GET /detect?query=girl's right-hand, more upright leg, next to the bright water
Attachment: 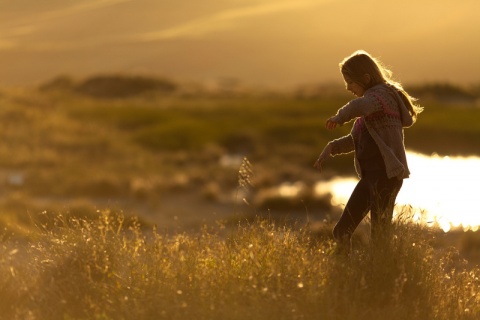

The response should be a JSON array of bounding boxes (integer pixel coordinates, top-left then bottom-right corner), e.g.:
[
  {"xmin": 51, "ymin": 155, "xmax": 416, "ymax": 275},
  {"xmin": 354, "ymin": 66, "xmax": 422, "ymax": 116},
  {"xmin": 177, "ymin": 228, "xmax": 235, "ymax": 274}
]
[{"xmin": 370, "ymin": 178, "xmax": 403, "ymax": 242}]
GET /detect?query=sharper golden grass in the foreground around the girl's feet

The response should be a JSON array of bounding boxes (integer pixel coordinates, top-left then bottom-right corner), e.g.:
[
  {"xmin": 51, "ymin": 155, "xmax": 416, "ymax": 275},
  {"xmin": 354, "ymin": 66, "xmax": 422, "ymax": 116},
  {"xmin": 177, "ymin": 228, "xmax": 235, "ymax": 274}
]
[{"xmin": 0, "ymin": 211, "xmax": 480, "ymax": 319}]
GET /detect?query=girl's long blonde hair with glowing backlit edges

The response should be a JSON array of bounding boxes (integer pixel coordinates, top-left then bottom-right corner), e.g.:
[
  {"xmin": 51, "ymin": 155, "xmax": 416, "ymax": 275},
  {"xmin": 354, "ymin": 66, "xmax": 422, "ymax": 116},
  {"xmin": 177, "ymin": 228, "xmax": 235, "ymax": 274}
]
[{"xmin": 340, "ymin": 50, "xmax": 423, "ymax": 121}]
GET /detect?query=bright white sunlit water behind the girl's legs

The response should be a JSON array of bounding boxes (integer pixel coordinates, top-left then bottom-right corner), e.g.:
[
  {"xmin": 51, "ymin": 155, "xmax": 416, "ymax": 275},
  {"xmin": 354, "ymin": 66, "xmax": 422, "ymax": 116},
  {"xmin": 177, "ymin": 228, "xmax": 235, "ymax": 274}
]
[{"xmin": 315, "ymin": 152, "xmax": 480, "ymax": 232}]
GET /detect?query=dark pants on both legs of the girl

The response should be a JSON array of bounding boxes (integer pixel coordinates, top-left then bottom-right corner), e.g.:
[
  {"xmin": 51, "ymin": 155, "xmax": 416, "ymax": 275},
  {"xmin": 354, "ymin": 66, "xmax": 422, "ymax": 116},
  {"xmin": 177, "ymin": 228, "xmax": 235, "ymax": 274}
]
[{"xmin": 333, "ymin": 171, "xmax": 403, "ymax": 247}]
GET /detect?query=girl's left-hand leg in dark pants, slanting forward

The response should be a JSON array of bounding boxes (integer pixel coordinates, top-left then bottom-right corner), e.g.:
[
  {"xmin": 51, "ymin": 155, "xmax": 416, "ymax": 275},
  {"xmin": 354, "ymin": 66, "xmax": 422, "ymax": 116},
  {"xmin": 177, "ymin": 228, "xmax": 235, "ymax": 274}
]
[{"xmin": 333, "ymin": 178, "xmax": 372, "ymax": 251}]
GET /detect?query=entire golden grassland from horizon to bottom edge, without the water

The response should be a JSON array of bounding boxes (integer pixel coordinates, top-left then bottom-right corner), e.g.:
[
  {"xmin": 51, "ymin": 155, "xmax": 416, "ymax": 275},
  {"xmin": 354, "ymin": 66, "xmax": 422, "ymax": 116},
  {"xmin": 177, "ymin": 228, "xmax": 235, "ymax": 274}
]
[{"xmin": 0, "ymin": 78, "xmax": 480, "ymax": 319}]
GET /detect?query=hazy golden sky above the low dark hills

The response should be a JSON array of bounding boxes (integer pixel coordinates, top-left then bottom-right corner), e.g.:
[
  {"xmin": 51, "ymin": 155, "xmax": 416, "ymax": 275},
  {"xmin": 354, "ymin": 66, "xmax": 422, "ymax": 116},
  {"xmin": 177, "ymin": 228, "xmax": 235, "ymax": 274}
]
[{"xmin": 0, "ymin": 0, "xmax": 480, "ymax": 87}]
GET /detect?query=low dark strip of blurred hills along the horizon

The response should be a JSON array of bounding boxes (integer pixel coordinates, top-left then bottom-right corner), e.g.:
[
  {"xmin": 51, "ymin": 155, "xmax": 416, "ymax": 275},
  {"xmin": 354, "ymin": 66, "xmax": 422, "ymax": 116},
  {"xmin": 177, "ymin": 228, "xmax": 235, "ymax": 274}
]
[{"xmin": 39, "ymin": 74, "xmax": 480, "ymax": 105}]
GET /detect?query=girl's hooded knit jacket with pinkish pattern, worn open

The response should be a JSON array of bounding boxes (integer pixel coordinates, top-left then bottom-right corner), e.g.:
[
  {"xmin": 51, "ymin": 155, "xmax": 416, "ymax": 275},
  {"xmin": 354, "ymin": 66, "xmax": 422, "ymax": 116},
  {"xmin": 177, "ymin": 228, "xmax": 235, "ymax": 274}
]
[{"xmin": 329, "ymin": 83, "xmax": 414, "ymax": 180}]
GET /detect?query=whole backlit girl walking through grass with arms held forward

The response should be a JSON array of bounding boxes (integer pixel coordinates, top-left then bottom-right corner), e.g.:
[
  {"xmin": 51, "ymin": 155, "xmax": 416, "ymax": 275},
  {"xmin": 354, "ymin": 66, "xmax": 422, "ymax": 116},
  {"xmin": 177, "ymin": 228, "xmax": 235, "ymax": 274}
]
[{"xmin": 314, "ymin": 51, "xmax": 422, "ymax": 252}]
